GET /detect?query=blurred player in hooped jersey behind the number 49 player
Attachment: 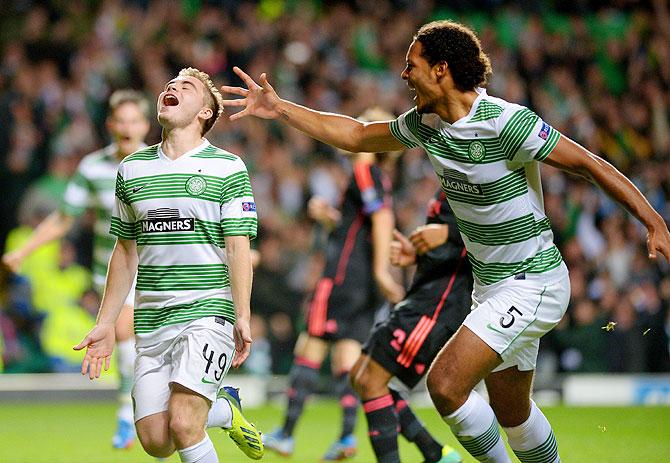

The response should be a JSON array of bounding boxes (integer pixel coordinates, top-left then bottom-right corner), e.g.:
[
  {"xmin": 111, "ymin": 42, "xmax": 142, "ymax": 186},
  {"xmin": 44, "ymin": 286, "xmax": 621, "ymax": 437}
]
[{"xmin": 2, "ymin": 90, "xmax": 149, "ymax": 448}]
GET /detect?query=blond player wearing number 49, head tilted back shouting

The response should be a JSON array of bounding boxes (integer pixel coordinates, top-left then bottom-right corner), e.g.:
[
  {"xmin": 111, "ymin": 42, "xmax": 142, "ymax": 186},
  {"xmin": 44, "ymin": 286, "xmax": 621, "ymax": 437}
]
[{"xmin": 75, "ymin": 68, "xmax": 263, "ymax": 463}]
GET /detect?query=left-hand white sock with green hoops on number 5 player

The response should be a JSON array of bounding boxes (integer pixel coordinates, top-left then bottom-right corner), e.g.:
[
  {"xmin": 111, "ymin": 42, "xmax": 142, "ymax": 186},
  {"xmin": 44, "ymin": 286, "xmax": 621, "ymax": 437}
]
[{"xmin": 442, "ymin": 391, "xmax": 512, "ymax": 463}]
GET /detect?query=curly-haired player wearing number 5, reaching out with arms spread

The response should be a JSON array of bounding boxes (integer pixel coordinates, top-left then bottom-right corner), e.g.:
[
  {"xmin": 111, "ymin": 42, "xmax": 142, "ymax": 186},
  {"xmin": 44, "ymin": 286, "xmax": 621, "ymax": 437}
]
[{"xmin": 223, "ymin": 21, "xmax": 670, "ymax": 463}]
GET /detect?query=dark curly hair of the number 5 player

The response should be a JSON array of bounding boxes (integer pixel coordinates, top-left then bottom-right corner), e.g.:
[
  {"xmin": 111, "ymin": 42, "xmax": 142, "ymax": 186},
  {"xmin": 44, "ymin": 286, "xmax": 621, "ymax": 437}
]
[{"xmin": 414, "ymin": 20, "xmax": 493, "ymax": 91}]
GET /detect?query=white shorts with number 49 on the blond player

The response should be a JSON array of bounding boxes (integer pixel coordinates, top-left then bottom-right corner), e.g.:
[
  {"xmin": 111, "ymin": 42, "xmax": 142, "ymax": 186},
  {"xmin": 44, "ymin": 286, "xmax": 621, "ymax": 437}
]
[{"xmin": 132, "ymin": 317, "xmax": 235, "ymax": 421}]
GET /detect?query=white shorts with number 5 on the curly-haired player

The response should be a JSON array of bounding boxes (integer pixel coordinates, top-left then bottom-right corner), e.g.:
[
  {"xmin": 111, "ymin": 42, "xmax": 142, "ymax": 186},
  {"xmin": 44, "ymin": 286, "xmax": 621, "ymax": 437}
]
[{"xmin": 463, "ymin": 264, "xmax": 570, "ymax": 371}]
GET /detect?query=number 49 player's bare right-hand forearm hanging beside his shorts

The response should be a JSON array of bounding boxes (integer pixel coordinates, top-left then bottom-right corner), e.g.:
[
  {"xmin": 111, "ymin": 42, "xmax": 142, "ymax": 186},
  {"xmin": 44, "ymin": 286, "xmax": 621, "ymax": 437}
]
[{"xmin": 225, "ymin": 235, "xmax": 253, "ymax": 368}]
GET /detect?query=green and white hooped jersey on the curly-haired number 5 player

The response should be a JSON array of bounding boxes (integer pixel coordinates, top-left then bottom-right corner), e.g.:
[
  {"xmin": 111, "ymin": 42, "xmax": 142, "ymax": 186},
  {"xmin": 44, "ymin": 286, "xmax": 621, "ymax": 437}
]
[{"xmin": 390, "ymin": 89, "xmax": 563, "ymax": 285}]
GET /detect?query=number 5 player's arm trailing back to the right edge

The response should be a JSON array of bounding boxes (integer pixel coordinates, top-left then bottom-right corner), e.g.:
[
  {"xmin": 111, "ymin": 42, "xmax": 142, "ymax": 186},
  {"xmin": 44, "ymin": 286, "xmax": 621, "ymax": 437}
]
[{"xmin": 544, "ymin": 136, "xmax": 670, "ymax": 260}]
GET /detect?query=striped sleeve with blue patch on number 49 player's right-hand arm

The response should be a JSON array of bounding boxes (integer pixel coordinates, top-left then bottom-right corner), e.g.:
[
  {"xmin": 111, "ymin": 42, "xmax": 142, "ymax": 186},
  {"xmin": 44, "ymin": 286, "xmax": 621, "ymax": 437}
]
[{"xmin": 220, "ymin": 159, "xmax": 258, "ymax": 239}]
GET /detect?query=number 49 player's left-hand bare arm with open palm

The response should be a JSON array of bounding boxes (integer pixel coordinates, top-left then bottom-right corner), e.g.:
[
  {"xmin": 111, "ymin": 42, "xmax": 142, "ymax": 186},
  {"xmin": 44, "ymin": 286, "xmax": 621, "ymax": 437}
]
[{"xmin": 73, "ymin": 239, "xmax": 137, "ymax": 379}]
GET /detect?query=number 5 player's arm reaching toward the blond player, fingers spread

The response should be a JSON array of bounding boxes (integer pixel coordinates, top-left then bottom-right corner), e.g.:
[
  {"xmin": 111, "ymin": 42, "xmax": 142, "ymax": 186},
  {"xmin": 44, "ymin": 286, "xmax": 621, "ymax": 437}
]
[{"xmin": 221, "ymin": 66, "xmax": 405, "ymax": 153}]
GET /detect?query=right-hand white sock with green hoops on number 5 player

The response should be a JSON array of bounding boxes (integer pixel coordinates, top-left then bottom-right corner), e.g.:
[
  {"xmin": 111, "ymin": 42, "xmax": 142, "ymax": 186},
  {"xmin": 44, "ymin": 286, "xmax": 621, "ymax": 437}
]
[{"xmin": 503, "ymin": 400, "xmax": 561, "ymax": 463}]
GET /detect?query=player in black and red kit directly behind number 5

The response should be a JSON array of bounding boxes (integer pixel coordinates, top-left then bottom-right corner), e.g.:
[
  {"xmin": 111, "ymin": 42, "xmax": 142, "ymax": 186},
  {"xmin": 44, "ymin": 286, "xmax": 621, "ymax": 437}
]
[{"xmin": 351, "ymin": 191, "xmax": 472, "ymax": 463}]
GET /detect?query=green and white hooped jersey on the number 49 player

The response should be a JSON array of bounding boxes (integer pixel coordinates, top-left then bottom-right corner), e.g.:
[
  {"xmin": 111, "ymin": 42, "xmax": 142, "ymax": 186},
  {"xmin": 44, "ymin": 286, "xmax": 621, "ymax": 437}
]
[{"xmin": 111, "ymin": 140, "xmax": 257, "ymax": 346}]
